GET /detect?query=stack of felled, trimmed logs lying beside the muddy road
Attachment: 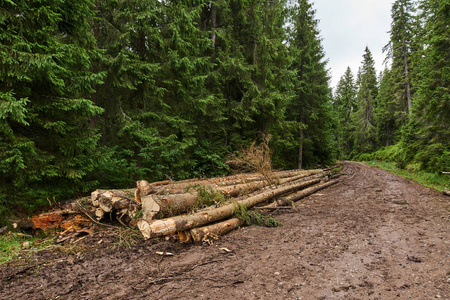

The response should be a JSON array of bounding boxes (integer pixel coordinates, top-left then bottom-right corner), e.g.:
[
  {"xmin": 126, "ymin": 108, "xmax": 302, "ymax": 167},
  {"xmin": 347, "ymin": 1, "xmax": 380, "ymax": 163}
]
[{"xmin": 90, "ymin": 169, "xmax": 337, "ymax": 242}]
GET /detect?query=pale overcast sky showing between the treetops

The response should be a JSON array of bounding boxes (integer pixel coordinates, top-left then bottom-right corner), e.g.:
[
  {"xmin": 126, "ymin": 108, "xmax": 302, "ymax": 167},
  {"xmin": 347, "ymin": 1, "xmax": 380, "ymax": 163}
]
[{"xmin": 312, "ymin": 0, "xmax": 394, "ymax": 88}]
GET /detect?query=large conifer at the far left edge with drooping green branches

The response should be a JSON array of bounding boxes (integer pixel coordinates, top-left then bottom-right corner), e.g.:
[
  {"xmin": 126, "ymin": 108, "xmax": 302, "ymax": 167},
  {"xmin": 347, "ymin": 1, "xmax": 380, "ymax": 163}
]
[{"xmin": 0, "ymin": 0, "xmax": 102, "ymax": 211}]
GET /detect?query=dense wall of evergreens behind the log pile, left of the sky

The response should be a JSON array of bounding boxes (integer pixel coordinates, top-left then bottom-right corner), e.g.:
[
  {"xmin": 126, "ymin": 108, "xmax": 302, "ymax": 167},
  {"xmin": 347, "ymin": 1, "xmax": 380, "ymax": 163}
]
[{"xmin": 0, "ymin": 0, "xmax": 338, "ymax": 218}]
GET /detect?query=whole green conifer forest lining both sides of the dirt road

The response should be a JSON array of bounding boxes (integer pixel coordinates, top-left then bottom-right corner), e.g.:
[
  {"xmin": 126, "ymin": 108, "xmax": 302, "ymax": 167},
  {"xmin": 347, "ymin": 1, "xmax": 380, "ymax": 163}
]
[{"xmin": 0, "ymin": 0, "xmax": 450, "ymax": 220}]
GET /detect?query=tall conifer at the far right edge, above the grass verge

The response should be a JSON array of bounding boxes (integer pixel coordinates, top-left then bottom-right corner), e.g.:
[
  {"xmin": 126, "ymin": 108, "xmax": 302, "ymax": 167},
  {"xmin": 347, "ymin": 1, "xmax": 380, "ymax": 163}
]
[{"xmin": 402, "ymin": 0, "xmax": 450, "ymax": 171}]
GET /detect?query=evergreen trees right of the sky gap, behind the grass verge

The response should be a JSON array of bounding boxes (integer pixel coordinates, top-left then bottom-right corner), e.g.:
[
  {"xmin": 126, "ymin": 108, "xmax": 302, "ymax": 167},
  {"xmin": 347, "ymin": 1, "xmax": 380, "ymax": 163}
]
[{"xmin": 334, "ymin": 0, "xmax": 450, "ymax": 176}]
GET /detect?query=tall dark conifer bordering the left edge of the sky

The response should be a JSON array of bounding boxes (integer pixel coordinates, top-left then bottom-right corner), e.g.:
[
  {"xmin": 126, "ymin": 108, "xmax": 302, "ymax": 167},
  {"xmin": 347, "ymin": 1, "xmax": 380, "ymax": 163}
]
[{"xmin": 288, "ymin": 0, "xmax": 332, "ymax": 168}]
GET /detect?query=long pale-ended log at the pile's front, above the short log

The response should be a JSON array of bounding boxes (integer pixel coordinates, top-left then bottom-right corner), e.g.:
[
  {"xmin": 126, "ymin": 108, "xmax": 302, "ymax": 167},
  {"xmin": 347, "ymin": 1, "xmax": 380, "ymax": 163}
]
[{"xmin": 137, "ymin": 179, "xmax": 324, "ymax": 239}]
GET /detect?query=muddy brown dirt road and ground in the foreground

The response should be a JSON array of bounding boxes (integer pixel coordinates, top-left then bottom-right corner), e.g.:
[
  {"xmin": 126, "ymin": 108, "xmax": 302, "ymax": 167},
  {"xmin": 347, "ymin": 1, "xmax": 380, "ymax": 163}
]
[{"xmin": 0, "ymin": 162, "xmax": 450, "ymax": 299}]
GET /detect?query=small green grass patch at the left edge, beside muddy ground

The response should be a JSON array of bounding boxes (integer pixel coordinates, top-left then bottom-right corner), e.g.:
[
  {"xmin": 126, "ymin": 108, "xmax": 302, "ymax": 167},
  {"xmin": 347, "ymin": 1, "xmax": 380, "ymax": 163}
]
[{"xmin": 0, "ymin": 233, "xmax": 53, "ymax": 264}]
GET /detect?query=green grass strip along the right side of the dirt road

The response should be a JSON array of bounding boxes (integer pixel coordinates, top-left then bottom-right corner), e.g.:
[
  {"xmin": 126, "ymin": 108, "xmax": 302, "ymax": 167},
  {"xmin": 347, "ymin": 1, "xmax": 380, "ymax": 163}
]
[{"xmin": 364, "ymin": 160, "xmax": 450, "ymax": 192}]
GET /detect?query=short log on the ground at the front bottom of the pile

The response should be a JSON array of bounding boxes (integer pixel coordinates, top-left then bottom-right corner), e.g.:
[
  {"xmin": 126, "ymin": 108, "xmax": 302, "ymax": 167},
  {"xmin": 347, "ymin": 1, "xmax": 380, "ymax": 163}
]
[{"xmin": 178, "ymin": 218, "xmax": 244, "ymax": 243}]
